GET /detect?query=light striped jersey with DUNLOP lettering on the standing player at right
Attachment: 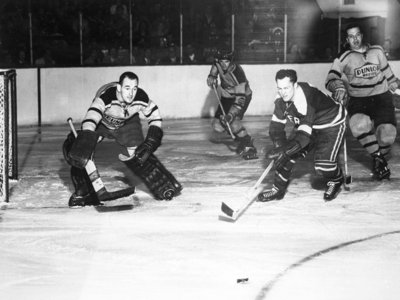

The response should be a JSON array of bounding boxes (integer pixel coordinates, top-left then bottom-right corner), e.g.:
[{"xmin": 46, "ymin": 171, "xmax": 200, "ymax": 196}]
[{"xmin": 326, "ymin": 45, "xmax": 396, "ymax": 97}]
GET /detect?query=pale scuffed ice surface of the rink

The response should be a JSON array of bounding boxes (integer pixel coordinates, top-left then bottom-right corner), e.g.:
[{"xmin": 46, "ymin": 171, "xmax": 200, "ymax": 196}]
[{"xmin": 0, "ymin": 117, "xmax": 400, "ymax": 300}]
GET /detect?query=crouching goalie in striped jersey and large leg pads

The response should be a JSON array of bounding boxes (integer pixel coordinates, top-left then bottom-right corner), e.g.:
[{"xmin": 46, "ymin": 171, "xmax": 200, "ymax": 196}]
[{"xmin": 63, "ymin": 72, "xmax": 182, "ymax": 206}]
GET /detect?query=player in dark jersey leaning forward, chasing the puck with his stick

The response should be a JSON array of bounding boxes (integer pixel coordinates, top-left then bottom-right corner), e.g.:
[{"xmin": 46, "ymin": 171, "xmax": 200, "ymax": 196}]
[{"xmin": 258, "ymin": 69, "xmax": 346, "ymax": 202}]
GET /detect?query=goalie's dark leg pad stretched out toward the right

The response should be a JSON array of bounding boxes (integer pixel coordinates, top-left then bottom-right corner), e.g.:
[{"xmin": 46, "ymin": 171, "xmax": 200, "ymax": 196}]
[{"xmin": 124, "ymin": 154, "xmax": 182, "ymax": 200}]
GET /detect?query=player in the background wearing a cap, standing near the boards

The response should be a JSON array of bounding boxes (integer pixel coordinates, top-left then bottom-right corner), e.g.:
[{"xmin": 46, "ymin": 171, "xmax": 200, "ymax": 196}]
[{"xmin": 207, "ymin": 50, "xmax": 257, "ymax": 159}]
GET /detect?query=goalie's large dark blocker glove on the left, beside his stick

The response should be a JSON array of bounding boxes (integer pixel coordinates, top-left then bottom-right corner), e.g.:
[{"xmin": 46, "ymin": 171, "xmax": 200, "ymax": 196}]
[{"xmin": 67, "ymin": 130, "xmax": 98, "ymax": 169}]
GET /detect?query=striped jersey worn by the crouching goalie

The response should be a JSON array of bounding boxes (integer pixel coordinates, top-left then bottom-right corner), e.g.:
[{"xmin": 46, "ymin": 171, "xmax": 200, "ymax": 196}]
[{"xmin": 82, "ymin": 82, "xmax": 162, "ymax": 131}]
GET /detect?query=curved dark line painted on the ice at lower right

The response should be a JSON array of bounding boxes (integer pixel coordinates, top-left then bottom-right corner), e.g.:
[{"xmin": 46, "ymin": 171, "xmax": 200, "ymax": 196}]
[{"xmin": 255, "ymin": 230, "xmax": 400, "ymax": 300}]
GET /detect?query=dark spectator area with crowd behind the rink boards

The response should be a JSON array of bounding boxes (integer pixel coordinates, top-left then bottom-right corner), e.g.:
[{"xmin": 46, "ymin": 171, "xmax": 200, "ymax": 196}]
[{"xmin": 0, "ymin": 0, "xmax": 400, "ymax": 67}]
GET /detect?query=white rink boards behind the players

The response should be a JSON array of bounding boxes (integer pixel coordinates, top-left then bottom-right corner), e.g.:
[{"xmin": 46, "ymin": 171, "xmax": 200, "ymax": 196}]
[{"xmin": 17, "ymin": 61, "xmax": 400, "ymax": 125}]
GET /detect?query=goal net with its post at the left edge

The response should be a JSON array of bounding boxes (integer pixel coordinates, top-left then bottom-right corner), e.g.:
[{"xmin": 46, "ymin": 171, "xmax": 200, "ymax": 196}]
[{"xmin": 0, "ymin": 69, "xmax": 18, "ymax": 202}]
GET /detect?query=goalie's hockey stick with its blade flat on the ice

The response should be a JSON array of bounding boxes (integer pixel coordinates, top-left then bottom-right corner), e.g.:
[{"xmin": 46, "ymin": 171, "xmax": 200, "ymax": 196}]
[{"xmin": 67, "ymin": 118, "xmax": 135, "ymax": 201}]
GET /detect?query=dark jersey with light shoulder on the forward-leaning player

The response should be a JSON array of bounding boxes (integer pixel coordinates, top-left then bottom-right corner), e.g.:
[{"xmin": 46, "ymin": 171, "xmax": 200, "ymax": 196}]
[{"xmin": 270, "ymin": 82, "xmax": 346, "ymax": 148}]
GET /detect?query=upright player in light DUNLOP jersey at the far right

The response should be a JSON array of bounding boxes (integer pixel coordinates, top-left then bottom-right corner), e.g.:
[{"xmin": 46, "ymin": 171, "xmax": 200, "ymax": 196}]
[{"xmin": 326, "ymin": 24, "xmax": 400, "ymax": 180}]
